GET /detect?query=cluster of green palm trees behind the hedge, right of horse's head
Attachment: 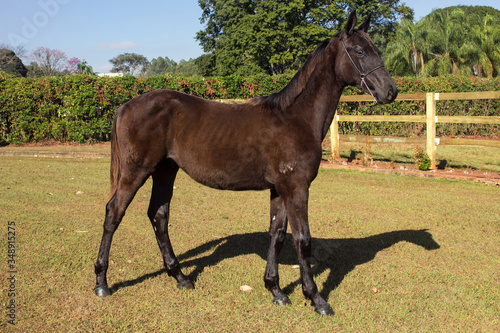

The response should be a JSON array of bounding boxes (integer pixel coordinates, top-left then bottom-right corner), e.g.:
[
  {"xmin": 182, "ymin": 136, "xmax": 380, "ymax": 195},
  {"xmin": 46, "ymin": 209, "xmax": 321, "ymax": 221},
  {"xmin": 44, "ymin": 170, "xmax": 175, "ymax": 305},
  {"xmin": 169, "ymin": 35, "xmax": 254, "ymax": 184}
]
[{"xmin": 386, "ymin": 6, "xmax": 500, "ymax": 77}]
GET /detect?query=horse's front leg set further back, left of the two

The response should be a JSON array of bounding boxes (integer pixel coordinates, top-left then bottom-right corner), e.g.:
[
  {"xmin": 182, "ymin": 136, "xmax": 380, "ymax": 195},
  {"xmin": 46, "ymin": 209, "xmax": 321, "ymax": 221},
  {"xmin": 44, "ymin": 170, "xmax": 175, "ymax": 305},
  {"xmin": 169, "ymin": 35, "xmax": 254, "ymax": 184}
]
[{"xmin": 264, "ymin": 190, "xmax": 291, "ymax": 305}]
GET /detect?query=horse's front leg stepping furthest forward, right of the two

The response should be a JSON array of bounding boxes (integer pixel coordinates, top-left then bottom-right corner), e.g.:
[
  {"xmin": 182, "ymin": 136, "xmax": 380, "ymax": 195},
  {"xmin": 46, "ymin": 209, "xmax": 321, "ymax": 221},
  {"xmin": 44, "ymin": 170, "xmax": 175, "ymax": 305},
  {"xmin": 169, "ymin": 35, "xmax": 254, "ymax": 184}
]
[{"xmin": 284, "ymin": 187, "xmax": 333, "ymax": 315}]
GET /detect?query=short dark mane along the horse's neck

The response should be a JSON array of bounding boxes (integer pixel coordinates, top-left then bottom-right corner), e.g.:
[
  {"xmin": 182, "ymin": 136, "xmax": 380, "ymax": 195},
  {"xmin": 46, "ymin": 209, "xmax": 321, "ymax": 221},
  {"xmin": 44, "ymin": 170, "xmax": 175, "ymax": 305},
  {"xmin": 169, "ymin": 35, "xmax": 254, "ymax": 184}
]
[{"xmin": 250, "ymin": 40, "xmax": 336, "ymax": 111}]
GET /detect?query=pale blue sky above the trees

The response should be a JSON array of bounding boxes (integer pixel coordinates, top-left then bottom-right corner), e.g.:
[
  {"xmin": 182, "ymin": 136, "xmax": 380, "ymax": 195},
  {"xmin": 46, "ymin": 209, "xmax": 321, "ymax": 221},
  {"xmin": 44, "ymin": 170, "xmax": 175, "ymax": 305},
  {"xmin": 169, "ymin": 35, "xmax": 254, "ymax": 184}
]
[{"xmin": 0, "ymin": 0, "xmax": 500, "ymax": 73}]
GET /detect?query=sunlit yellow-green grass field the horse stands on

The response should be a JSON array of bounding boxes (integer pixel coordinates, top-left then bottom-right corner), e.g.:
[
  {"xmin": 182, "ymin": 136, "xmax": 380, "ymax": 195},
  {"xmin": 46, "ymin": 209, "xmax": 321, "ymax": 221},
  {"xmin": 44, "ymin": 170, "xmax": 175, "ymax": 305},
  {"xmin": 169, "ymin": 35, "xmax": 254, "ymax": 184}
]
[{"xmin": 0, "ymin": 152, "xmax": 500, "ymax": 332}]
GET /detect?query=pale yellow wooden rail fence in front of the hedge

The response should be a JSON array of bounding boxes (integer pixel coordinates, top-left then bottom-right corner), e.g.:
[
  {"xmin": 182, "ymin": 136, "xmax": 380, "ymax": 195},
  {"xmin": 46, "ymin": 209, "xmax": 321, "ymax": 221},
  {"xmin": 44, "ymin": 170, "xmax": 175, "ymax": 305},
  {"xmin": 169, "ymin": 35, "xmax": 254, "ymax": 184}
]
[{"xmin": 330, "ymin": 91, "xmax": 500, "ymax": 169}]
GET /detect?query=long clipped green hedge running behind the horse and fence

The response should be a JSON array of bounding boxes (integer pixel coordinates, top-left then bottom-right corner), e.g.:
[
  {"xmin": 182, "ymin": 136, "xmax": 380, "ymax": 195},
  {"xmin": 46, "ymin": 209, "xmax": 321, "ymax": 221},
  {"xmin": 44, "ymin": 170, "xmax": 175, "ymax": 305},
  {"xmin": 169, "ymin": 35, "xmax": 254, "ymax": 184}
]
[{"xmin": 0, "ymin": 75, "xmax": 500, "ymax": 144}]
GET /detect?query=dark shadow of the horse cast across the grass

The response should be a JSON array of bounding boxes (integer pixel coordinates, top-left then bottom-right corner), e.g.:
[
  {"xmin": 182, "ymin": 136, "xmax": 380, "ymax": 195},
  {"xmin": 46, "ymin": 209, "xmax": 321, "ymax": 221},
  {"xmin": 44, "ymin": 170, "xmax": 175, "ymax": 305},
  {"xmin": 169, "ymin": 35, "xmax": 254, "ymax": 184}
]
[{"xmin": 111, "ymin": 229, "xmax": 440, "ymax": 298}]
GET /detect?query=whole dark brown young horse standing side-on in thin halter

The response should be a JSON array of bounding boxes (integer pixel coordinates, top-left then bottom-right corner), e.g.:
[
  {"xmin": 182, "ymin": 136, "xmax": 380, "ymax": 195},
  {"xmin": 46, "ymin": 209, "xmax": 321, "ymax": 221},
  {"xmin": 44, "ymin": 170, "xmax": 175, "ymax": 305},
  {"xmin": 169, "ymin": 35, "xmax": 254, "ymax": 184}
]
[{"xmin": 94, "ymin": 12, "xmax": 397, "ymax": 314}]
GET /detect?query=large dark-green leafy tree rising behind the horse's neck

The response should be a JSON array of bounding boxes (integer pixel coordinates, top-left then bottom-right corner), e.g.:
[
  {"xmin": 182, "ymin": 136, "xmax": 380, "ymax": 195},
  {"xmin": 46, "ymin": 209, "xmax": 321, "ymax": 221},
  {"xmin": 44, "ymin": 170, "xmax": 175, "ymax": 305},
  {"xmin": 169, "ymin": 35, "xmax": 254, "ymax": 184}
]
[{"xmin": 196, "ymin": 0, "xmax": 413, "ymax": 75}]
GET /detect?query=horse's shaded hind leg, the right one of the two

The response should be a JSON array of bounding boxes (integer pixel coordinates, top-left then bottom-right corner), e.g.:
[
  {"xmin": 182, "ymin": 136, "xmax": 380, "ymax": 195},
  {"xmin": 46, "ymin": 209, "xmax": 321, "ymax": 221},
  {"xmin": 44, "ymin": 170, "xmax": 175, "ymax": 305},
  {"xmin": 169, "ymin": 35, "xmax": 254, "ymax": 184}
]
[{"xmin": 148, "ymin": 160, "xmax": 194, "ymax": 289}]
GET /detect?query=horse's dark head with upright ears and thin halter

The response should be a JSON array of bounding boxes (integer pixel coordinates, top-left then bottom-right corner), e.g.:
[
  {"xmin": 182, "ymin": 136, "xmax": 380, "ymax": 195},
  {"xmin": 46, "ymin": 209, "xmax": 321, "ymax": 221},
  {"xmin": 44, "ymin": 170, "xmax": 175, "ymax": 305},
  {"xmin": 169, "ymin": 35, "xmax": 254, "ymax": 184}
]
[{"xmin": 336, "ymin": 10, "xmax": 398, "ymax": 104}]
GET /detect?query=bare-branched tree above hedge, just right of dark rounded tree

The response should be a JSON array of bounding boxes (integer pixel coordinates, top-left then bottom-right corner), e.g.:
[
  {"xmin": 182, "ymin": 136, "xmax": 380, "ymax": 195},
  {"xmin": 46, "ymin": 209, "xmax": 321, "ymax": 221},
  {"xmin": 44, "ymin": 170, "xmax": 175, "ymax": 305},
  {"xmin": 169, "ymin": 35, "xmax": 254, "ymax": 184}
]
[{"xmin": 29, "ymin": 47, "xmax": 68, "ymax": 76}]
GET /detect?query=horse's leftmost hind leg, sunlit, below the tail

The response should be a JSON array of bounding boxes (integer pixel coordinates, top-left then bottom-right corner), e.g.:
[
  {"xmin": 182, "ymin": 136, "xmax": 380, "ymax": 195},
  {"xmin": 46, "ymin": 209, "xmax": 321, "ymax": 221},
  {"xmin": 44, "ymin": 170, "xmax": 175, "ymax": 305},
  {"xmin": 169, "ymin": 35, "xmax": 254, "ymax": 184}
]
[{"xmin": 94, "ymin": 167, "xmax": 149, "ymax": 296}]
